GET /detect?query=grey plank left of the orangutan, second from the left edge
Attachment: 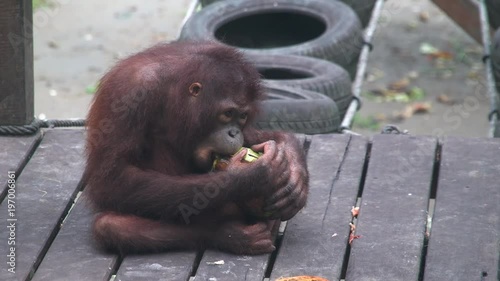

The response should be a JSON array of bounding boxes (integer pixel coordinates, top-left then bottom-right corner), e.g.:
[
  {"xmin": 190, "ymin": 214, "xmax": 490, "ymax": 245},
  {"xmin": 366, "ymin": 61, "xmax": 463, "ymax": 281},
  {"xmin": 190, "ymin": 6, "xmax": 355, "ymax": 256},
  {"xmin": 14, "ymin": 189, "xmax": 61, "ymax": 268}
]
[{"xmin": 0, "ymin": 130, "xmax": 84, "ymax": 280}]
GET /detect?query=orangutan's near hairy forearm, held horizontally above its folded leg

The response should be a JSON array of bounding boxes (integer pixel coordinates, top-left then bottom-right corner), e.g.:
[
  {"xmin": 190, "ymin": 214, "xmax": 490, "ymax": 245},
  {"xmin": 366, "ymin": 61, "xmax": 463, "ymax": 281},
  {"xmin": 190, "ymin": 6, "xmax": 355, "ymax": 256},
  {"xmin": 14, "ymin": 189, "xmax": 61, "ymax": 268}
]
[{"xmin": 88, "ymin": 164, "xmax": 258, "ymax": 218}]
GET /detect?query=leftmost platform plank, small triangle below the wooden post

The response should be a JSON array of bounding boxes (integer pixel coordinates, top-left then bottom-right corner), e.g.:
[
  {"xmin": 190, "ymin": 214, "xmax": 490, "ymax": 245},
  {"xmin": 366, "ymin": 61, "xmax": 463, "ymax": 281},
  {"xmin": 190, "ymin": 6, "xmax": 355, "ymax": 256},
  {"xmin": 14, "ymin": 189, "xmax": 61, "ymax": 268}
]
[{"xmin": 0, "ymin": 133, "xmax": 41, "ymax": 198}]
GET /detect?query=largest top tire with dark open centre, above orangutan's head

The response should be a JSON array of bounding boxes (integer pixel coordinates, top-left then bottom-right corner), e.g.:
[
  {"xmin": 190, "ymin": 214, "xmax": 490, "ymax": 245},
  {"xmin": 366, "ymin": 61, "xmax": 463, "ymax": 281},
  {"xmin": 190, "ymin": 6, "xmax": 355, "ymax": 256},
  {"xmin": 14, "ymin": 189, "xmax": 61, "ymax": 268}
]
[{"xmin": 180, "ymin": 0, "xmax": 364, "ymax": 77}]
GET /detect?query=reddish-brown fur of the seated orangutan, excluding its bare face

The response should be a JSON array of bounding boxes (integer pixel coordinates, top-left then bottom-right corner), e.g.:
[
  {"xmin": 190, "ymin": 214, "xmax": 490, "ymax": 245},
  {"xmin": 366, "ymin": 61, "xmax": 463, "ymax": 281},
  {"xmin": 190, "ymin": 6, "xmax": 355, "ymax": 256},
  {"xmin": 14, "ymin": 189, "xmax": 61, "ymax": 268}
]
[{"xmin": 84, "ymin": 42, "xmax": 308, "ymax": 253}]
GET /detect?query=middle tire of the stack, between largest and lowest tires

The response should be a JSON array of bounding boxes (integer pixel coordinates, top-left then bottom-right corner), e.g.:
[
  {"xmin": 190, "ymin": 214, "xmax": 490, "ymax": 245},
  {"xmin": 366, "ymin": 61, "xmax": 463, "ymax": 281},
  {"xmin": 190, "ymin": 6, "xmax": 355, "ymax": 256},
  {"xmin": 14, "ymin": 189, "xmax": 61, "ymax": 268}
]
[{"xmin": 247, "ymin": 55, "xmax": 352, "ymax": 118}]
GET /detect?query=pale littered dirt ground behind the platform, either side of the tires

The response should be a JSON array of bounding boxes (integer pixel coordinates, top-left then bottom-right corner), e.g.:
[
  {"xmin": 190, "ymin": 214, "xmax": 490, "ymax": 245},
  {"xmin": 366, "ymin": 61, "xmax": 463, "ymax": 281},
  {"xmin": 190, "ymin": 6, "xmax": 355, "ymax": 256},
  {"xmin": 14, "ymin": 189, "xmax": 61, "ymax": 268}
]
[{"xmin": 34, "ymin": 0, "xmax": 489, "ymax": 137}]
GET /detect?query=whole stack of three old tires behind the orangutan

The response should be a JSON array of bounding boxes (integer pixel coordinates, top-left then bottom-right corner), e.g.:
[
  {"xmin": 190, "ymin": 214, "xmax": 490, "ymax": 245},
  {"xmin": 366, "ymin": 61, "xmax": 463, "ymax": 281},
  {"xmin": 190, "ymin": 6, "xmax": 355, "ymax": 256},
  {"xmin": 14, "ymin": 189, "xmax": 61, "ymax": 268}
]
[{"xmin": 180, "ymin": 0, "xmax": 375, "ymax": 134}]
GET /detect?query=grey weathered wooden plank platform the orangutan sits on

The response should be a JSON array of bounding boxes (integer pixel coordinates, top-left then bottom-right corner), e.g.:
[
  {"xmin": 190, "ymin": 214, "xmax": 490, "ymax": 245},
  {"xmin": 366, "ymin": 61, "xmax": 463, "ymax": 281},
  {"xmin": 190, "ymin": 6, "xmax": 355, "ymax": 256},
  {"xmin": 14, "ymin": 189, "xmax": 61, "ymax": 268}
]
[{"xmin": 0, "ymin": 129, "xmax": 500, "ymax": 281}]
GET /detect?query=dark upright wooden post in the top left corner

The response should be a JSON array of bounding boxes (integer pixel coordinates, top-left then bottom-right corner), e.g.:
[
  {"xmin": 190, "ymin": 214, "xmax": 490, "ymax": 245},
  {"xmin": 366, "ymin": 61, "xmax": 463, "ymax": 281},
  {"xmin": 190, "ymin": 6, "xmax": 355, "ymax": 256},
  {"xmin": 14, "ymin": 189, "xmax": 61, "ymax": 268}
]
[{"xmin": 0, "ymin": 0, "xmax": 34, "ymax": 125}]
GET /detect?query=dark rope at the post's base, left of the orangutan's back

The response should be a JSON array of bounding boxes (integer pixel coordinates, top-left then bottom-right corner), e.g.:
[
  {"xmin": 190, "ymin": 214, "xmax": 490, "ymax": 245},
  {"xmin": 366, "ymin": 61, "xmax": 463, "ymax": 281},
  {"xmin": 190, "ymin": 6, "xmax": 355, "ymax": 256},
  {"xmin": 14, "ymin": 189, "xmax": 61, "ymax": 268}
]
[{"xmin": 0, "ymin": 119, "xmax": 85, "ymax": 136}]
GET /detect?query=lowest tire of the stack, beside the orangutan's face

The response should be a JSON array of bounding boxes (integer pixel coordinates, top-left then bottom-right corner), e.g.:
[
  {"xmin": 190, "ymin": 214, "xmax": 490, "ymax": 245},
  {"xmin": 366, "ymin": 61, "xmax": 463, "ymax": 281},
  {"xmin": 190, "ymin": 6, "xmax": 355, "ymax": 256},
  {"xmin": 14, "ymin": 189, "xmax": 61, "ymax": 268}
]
[{"xmin": 255, "ymin": 85, "xmax": 340, "ymax": 134}]
